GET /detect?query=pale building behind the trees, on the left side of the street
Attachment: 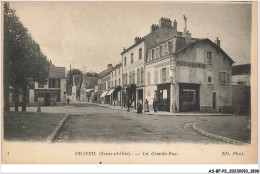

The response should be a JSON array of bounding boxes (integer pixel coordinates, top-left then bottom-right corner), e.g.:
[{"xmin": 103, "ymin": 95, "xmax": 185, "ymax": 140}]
[{"xmin": 29, "ymin": 63, "xmax": 66, "ymax": 106}]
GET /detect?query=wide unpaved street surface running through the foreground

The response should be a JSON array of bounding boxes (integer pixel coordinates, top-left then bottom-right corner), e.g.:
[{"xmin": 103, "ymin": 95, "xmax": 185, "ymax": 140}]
[{"xmin": 55, "ymin": 103, "xmax": 223, "ymax": 144}]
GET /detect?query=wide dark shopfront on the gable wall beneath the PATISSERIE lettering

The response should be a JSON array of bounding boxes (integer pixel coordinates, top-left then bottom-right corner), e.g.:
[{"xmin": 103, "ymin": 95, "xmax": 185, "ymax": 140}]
[{"xmin": 179, "ymin": 83, "xmax": 200, "ymax": 112}]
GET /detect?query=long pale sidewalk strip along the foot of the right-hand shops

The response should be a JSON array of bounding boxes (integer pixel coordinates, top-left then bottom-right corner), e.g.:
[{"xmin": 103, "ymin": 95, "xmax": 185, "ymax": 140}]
[{"xmin": 85, "ymin": 102, "xmax": 234, "ymax": 116}]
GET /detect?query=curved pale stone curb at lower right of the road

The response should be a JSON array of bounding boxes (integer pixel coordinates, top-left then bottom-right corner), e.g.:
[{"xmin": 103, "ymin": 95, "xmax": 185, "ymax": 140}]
[{"xmin": 192, "ymin": 122, "xmax": 248, "ymax": 145}]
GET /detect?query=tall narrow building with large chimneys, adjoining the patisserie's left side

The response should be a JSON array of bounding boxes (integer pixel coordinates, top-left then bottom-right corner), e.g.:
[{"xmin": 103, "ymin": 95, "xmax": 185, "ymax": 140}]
[{"xmin": 121, "ymin": 17, "xmax": 182, "ymax": 108}]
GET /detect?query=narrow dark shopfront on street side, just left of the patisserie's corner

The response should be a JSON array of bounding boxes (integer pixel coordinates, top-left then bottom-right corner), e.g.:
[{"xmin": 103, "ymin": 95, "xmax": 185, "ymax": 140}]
[{"xmin": 157, "ymin": 83, "xmax": 171, "ymax": 112}]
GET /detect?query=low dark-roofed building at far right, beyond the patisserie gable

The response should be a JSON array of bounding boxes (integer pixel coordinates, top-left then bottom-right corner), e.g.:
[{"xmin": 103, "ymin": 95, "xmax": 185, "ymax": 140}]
[{"xmin": 231, "ymin": 64, "xmax": 251, "ymax": 86}]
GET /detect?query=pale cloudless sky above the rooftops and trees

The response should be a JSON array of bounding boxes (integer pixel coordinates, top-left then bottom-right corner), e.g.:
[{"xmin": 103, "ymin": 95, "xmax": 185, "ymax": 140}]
[{"xmin": 10, "ymin": 1, "xmax": 252, "ymax": 72}]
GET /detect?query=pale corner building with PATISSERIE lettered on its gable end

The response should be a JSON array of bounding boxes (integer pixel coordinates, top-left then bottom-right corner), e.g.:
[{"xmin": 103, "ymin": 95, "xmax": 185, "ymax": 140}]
[{"xmin": 145, "ymin": 34, "xmax": 234, "ymax": 112}]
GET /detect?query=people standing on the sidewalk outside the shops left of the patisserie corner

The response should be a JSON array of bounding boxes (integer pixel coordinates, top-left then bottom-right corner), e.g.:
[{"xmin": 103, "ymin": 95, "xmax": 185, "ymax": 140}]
[{"xmin": 127, "ymin": 98, "xmax": 158, "ymax": 114}]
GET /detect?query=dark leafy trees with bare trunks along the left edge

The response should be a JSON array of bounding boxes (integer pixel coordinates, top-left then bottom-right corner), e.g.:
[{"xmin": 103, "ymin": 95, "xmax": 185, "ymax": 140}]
[{"xmin": 3, "ymin": 2, "xmax": 48, "ymax": 111}]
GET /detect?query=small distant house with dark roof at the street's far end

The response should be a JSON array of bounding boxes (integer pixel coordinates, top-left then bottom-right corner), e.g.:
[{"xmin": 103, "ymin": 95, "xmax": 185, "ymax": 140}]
[{"xmin": 80, "ymin": 74, "xmax": 98, "ymax": 102}]
